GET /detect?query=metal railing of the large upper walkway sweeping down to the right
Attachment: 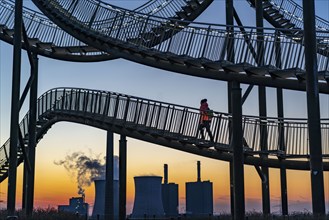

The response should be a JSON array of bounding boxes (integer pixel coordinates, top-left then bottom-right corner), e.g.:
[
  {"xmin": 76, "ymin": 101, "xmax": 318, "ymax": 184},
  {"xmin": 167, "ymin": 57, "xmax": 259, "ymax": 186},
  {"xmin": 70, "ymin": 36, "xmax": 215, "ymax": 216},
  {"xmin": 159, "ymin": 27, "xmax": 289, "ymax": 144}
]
[{"xmin": 35, "ymin": 0, "xmax": 329, "ymax": 80}]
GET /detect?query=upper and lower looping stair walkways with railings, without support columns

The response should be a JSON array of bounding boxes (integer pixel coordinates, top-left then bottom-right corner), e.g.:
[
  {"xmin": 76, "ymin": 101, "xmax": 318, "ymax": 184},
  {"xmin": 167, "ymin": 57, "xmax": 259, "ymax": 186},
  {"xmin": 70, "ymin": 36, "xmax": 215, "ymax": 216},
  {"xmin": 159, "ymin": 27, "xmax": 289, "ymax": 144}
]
[{"xmin": 0, "ymin": 0, "xmax": 329, "ymax": 181}]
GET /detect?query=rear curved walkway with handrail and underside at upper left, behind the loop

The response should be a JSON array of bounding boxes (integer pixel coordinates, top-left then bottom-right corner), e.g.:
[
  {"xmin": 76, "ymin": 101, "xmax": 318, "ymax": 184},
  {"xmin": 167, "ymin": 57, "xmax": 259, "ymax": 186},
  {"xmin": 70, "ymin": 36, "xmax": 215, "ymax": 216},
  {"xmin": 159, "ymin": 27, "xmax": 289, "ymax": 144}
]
[{"xmin": 0, "ymin": 0, "xmax": 210, "ymax": 61}]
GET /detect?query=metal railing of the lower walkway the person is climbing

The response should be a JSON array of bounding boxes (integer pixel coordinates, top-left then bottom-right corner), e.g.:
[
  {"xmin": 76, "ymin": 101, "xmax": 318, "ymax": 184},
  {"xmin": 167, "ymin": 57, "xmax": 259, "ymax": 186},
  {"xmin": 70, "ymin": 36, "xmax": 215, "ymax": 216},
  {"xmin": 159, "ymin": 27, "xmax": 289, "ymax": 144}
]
[{"xmin": 0, "ymin": 88, "xmax": 329, "ymax": 167}]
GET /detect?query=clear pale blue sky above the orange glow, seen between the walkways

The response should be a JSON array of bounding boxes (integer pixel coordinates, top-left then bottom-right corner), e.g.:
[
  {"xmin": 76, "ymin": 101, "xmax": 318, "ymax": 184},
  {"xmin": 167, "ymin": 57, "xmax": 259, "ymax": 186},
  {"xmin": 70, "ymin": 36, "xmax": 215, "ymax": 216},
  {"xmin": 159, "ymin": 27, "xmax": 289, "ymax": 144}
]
[{"xmin": 0, "ymin": 0, "xmax": 329, "ymax": 215}]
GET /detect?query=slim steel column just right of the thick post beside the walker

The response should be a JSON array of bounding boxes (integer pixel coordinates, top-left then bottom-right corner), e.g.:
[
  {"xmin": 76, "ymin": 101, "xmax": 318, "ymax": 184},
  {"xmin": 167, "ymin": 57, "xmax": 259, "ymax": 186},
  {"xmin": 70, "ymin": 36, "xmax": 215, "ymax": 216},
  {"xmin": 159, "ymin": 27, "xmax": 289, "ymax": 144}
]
[{"xmin": 256, "ymin": 0, "xmax": 270, "ymax": 215}]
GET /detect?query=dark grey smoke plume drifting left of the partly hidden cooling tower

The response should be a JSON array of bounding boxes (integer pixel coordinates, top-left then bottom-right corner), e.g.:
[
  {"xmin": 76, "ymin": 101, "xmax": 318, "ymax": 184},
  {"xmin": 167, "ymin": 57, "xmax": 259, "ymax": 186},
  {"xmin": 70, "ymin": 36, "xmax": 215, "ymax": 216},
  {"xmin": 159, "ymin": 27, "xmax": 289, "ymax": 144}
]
[{"xmin": 54, "ymin": 152, "xmax": 119, "ymax": 197}]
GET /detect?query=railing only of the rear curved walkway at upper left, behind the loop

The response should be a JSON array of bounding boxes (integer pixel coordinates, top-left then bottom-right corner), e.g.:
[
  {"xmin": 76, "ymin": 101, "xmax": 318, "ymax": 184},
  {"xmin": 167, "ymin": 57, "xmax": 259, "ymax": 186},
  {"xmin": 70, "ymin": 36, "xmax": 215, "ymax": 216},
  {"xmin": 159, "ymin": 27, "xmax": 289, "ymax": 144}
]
[{"xmin": 0, "ymin": 0, "xmax": 208, "ymax": 56}]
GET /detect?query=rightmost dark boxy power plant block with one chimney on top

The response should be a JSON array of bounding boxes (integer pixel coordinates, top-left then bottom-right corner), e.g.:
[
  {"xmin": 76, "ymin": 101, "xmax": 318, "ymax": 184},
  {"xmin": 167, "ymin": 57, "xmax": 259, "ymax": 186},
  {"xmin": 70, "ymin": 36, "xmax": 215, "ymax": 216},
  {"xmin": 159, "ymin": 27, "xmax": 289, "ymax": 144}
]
[{"xmin": 186, "ymin": 161, "xmax": 213, "ymax": 216}]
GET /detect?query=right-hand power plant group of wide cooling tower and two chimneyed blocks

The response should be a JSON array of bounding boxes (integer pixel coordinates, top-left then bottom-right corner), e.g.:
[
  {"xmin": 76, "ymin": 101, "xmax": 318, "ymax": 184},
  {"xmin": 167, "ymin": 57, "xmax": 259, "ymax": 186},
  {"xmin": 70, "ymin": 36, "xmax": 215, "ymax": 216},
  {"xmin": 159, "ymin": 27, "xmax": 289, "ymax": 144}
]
[{"xmin": 131, "ymin": 161, "xmax": 213, "ymax": 219}]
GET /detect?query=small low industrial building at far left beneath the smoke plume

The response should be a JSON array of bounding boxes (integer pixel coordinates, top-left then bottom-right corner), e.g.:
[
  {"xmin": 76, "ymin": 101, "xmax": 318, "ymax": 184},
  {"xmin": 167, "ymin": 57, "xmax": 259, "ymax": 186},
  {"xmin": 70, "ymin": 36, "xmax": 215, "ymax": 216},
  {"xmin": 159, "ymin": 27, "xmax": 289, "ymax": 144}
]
[{"xmin": 58, "ymin": 197, "xmax": 89, "ymax": 215}]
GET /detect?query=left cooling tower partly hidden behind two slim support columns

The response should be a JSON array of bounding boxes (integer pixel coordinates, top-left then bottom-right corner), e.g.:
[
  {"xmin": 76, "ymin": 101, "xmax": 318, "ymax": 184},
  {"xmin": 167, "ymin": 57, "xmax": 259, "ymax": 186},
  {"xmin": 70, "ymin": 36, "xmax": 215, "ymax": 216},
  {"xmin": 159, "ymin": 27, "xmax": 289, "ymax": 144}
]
[{"xmin": 92, "ymin": 180, "xmax": 119, "ymax": 219}]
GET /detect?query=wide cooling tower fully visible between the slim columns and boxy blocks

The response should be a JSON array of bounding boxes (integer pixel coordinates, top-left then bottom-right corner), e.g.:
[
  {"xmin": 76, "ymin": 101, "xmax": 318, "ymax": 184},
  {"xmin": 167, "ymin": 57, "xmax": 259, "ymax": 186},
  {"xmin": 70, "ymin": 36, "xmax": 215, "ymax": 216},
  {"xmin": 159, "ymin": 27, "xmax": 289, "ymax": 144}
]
[{"xmin": 131, "ymin": 176, "xmax": 164, "ymax": 218}]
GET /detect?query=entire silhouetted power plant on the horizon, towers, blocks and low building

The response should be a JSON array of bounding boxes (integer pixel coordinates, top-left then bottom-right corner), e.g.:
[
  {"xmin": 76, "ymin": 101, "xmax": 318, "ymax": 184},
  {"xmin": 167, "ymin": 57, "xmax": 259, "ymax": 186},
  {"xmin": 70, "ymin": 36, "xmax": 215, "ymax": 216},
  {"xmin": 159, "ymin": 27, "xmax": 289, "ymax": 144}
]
[{"xmin": 58, "ymin": 161, "xmax": 213, "ymax": 220}]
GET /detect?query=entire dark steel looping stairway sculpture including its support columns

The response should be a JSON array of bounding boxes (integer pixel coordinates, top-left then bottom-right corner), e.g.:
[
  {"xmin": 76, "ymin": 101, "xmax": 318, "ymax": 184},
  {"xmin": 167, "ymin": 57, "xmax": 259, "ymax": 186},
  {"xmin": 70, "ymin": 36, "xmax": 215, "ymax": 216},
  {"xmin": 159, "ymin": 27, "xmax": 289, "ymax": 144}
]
[{"xmin": 0, "ymin": 0, "xmax": 329, "ymax": 219}]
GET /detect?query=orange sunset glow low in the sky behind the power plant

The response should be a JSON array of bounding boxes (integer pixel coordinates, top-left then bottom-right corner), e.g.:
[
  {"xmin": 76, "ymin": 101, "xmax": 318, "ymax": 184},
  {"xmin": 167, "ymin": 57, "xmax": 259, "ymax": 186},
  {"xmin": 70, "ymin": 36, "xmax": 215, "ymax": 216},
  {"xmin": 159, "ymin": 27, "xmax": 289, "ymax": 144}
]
[{"xmin": 0, "ymin": 129, "xmax": 329, "ymax": 214}]
